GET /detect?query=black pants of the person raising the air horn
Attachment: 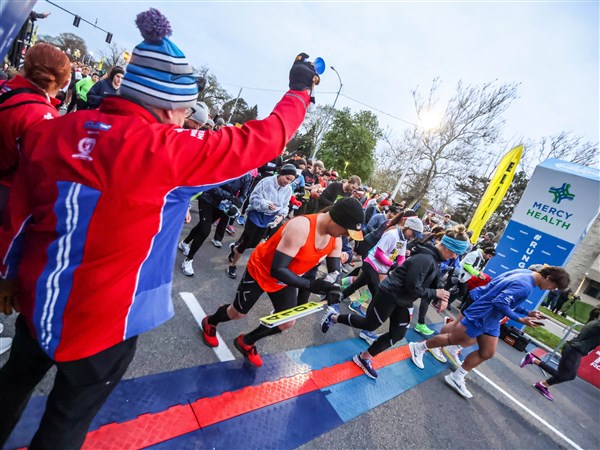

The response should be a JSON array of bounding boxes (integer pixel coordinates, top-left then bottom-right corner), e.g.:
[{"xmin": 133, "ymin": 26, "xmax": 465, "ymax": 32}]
[{"xmin": 0, "ymin": 315, "xmax": 137, "ymax": 449}]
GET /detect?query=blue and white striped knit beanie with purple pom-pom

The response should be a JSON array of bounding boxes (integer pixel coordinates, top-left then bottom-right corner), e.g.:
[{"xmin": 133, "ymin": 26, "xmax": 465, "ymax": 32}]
[{"xmin": 120, "ymin": 8, "xmax": 198, "ymax": 110}]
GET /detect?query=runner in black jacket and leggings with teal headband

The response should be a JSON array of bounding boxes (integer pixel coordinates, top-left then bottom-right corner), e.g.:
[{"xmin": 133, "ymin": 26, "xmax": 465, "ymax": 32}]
[{"xmin": 321, "ymin": 225, "xmax": 467, "ymax": 379}]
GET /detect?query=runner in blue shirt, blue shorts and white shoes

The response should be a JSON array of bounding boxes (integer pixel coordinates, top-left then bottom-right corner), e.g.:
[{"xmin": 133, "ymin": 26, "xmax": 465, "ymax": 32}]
[{"xmin": 408, "ymin": 267, "xmax": 570, "ymax": 398}]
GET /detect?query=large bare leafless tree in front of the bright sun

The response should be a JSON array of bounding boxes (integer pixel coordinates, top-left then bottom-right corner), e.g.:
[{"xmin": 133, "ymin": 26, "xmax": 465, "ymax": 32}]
[{"xmin": 381, "ymin": 79, "xmax": 518, "ymax": 203}]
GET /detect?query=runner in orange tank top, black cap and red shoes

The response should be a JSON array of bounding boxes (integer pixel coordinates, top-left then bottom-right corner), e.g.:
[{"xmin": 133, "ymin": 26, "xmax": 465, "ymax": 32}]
[{"xmin": 202, "ymin": 198, "xmax": 364, "ymax": 367}]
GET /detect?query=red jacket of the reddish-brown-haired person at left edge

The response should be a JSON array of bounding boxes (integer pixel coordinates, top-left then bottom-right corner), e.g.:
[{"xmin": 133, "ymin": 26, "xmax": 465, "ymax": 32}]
[{"xmin": 0, "ymin": 75, "xmax": 60, "ymax": 187}]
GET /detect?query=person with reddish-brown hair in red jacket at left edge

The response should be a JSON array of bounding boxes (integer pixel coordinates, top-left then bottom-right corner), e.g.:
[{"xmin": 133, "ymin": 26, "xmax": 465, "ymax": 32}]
[{"xmin": 0, "ymin": 43, "xmax": 71, "ymax": 216}]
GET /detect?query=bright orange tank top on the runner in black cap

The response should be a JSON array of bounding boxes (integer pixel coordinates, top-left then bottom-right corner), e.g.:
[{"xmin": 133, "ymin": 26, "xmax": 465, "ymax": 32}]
[{"xmin": 246, "ymin": 214, "xmax": 336, "ymax": 292}]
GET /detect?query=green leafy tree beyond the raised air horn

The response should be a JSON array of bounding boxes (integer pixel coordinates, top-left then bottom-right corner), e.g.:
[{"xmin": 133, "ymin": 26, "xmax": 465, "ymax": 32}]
[{"xmin": 317, "ymin": 108, "xmax": 382, "ymax": 180}]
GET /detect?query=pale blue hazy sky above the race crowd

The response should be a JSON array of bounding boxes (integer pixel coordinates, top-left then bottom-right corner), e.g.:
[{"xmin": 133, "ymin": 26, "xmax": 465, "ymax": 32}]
[{"xmin": 34, "ymin": 0, "xmax": 600, "ymax": 155}]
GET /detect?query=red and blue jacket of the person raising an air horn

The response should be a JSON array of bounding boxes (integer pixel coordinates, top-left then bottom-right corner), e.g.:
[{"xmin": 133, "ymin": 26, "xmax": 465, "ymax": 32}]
[{"xmin": 0, "ymin": 91, "xmax": 309, "ymax": 361}]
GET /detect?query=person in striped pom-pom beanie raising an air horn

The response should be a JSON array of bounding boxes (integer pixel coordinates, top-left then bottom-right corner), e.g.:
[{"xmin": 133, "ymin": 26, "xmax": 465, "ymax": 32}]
[{"xmin": 0, "ymin": 9, "xmax": 318, "ymax": 449}]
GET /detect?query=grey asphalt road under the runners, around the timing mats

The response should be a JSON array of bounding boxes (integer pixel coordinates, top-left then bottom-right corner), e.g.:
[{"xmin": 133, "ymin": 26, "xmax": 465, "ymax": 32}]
[{"xmin": 0, "ymin": 217, "xmax": 600, "ymax": 449}]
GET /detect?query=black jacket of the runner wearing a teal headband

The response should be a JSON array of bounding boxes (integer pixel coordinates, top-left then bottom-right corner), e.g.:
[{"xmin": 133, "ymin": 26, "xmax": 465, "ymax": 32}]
[{"xmin": 379, "ymin": 244, "xmax": 444, "ymax": 307}]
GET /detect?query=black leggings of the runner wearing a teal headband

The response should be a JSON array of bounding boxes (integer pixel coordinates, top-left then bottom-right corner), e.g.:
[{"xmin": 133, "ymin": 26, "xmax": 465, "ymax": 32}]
[{"xmin": 338, "ymin": 289, "xmax": 412, "ymax": 356}]
